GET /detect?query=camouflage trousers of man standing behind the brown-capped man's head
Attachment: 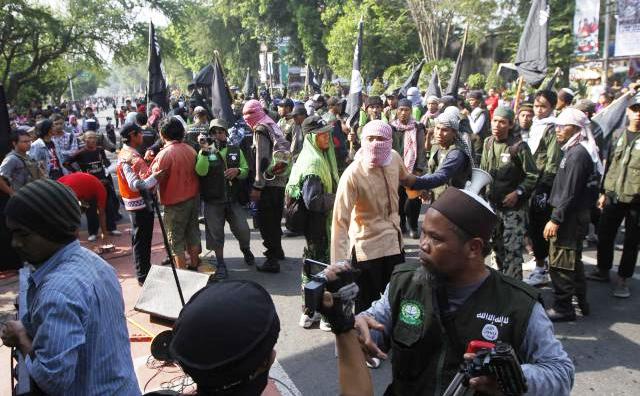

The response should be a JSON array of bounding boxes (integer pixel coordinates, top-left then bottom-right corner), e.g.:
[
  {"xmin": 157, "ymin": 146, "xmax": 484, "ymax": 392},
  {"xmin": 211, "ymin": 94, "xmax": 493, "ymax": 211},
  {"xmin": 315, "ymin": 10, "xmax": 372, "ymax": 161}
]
[{"xmin": 491, "ymin": 208, "xmax": 527, "ymax": 280}]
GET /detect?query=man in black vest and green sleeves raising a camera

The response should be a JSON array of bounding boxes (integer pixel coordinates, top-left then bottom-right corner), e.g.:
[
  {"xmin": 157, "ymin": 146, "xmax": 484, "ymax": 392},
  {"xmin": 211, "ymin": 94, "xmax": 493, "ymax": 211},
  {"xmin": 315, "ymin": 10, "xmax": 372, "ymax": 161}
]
[{"xmin": 196, "ymin": 119, "xmax": 255, "ymax": 279}]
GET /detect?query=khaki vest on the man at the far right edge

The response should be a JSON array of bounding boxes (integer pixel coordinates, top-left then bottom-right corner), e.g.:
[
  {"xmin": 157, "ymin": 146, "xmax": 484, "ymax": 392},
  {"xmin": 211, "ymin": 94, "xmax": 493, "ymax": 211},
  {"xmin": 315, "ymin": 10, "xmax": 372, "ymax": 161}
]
[{"xmin": 604, "ymin": 131, "xmax": 640, "ymax": 203}]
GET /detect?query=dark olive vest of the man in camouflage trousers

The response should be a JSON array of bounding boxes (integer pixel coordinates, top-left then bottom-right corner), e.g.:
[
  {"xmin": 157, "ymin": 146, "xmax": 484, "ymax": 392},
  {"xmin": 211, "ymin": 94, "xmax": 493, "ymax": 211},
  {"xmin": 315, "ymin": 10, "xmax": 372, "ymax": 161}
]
[{"xmin": 483, "ymin": 134, "xmax": 526, "ymax": 208}]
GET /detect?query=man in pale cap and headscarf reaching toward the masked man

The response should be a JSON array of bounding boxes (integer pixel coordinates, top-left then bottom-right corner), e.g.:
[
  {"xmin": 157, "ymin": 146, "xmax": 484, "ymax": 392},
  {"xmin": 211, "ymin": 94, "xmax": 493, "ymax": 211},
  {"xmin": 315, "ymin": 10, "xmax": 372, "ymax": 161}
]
[{"xmin": 409, "ymin": 111, "xmax": 473, "ymax": 206}]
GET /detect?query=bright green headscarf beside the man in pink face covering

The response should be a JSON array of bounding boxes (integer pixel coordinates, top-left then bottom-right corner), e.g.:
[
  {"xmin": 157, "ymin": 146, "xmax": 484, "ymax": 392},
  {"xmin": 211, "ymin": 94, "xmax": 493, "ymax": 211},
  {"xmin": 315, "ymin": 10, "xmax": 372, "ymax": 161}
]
[{"xmin": 286, "ymin": 132, "xmax": 340, "ymax": 199}]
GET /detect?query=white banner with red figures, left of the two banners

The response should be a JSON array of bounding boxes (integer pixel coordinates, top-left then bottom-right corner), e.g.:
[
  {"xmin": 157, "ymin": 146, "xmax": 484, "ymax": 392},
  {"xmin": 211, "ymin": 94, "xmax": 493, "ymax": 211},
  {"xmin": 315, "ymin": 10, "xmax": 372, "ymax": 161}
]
[{"xmin": 573, "ymin": 0, "xmax": 600, "ymax": 56}]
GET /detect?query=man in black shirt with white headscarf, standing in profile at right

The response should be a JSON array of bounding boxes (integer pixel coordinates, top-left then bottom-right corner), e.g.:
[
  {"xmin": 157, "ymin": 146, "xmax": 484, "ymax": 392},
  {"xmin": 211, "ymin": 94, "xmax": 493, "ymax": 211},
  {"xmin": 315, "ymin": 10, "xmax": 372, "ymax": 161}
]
[{"xmin": 544, "ymin": 108, "xmax": 604, "ymax": 321}]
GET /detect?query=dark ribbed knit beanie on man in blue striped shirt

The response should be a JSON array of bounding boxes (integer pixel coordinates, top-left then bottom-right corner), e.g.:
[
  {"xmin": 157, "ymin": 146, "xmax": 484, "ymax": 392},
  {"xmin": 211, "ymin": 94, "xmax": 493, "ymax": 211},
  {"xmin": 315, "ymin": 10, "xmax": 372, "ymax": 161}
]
[{"xmin": 5, "ymin": 179, "xmax": 80, "ymax": 243}]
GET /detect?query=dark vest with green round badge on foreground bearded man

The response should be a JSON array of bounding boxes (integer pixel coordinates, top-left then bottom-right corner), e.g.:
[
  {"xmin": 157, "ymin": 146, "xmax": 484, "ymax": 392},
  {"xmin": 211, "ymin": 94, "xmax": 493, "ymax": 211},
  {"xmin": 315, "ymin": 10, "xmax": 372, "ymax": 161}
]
[{"xmin": 389, "ymin": 263, "xmax": 540, "ymax": 396}]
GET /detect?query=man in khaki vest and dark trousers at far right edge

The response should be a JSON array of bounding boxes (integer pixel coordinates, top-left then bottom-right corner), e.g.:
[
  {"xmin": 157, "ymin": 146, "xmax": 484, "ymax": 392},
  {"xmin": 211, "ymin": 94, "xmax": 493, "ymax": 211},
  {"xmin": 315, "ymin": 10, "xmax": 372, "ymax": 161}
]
[{"xmin": 587, "ymin": 93, "xmax": 640, "ymax": 298}]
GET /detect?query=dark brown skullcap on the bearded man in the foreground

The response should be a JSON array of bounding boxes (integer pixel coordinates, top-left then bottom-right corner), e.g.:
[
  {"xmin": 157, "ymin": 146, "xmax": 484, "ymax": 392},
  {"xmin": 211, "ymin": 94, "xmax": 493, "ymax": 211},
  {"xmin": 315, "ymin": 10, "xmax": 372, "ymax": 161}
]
[{"xmin": 430, "ymin": 187, "xmax": 498, "ymax": 241}]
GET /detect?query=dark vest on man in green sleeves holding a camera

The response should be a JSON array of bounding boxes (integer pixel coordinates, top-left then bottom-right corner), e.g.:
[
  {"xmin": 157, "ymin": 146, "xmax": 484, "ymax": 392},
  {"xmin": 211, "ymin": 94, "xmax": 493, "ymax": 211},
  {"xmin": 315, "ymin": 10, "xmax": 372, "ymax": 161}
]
[{"xmin": 200, "ymin": 146, "xmax": 240, "ymax": 202}]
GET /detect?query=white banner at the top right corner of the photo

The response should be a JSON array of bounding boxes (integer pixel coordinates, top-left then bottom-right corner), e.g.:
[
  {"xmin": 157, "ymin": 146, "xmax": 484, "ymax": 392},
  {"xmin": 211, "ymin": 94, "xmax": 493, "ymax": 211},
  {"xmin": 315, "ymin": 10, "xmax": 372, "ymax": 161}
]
[{"xmin": 615, "ymin": 0, "xmax": 640, "ymax": 56}]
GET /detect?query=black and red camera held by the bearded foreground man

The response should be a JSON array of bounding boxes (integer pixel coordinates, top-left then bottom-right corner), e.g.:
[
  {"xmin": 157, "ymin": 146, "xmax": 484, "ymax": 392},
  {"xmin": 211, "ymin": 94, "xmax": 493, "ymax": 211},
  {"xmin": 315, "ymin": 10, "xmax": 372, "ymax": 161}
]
[{"xmin": 443, "ymin": 340, "xmax": 527, "ymax": 396}]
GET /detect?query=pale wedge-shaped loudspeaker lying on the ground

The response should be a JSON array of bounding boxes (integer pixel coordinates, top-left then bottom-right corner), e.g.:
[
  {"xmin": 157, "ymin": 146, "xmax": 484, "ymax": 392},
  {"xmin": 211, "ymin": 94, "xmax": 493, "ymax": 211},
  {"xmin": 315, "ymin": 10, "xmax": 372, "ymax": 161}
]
[{"xmin": 133, "ymin": 265, "xmax": 209, "ymax": 321}]
